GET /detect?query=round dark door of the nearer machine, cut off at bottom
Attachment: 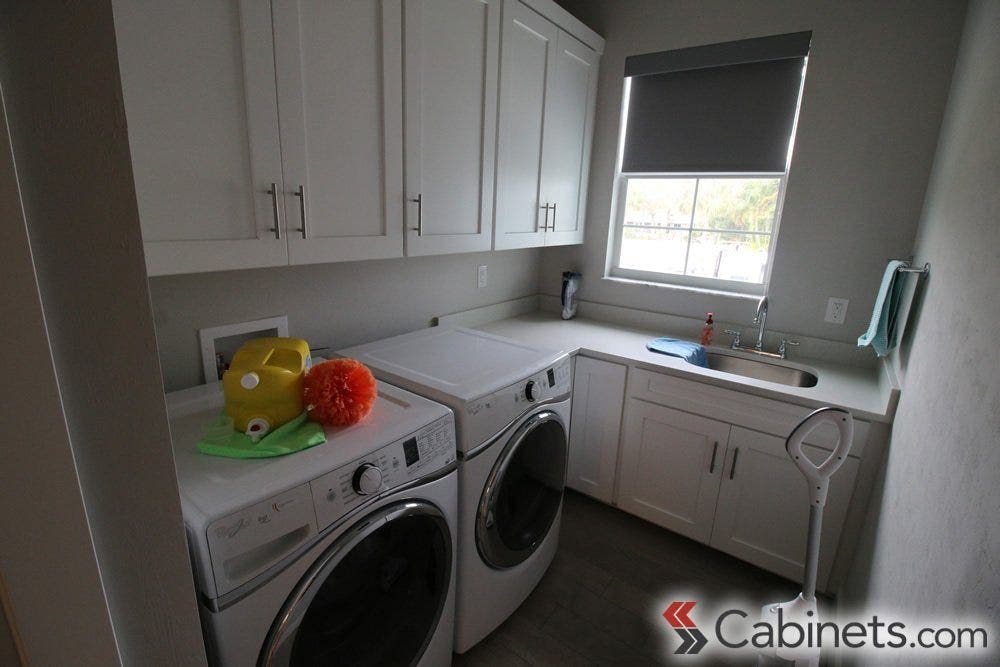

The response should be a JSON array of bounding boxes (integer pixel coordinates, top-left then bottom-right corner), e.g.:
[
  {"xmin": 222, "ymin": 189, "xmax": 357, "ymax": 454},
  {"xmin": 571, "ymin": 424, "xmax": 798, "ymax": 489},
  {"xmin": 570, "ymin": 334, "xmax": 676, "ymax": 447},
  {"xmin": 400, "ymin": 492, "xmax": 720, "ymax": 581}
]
[{"xmin": 259, "ymin": 501, "xmax": 452, "ymax": 667}]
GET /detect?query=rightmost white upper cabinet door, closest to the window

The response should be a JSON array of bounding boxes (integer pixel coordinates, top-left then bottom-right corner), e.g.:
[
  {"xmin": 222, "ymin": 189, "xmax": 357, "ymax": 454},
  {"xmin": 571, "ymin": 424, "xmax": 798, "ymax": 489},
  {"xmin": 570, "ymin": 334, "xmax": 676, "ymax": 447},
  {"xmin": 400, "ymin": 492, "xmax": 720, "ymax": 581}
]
[{"xmin": 541, "ymin": 30, "xmax": 598, "ymax": 245}]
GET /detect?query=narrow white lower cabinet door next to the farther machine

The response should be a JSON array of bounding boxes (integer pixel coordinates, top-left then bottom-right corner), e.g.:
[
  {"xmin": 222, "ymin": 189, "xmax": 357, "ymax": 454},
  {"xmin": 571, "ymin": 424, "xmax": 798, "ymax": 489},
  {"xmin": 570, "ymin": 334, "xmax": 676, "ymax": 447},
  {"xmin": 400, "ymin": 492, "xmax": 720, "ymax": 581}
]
[{"xmin": 566, "ymin": 356, "xmax": 626, "ymax": 503}]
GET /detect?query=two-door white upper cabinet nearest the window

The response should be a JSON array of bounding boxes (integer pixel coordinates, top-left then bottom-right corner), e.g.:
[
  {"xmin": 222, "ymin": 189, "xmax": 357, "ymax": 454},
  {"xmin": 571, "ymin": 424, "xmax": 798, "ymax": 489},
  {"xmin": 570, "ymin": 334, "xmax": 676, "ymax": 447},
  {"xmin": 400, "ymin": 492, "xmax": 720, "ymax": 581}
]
[{"xmin": 494, "ymin": 0, "xmax": 602, "ymax": 250}]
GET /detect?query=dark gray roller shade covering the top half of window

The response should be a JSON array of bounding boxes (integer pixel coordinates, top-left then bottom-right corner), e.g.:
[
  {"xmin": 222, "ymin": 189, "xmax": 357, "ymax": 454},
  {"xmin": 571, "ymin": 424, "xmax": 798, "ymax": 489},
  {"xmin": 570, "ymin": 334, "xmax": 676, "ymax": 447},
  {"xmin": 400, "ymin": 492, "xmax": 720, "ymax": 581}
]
[{"xmin": 622, "ymin": 33, "xmax": 810, "ymax": 172}]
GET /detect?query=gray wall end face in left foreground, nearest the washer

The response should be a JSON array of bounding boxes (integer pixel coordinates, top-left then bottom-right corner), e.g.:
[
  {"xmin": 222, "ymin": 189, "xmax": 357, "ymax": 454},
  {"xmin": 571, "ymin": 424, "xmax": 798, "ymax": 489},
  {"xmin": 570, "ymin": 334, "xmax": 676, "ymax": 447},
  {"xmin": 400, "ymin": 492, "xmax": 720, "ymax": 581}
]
[{"xmin": 0, "ymin": 0, "xmax": 205, "ymax": 665}]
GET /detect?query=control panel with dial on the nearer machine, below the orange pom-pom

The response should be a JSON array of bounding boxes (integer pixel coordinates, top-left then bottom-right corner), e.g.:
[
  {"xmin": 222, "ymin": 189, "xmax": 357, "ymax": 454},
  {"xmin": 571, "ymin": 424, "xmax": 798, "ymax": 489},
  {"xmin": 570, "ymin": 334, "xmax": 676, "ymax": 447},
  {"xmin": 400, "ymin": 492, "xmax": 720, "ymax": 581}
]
[{"xmin": 309, "ymin": 415, "xmax": 455, "ymax": 531}]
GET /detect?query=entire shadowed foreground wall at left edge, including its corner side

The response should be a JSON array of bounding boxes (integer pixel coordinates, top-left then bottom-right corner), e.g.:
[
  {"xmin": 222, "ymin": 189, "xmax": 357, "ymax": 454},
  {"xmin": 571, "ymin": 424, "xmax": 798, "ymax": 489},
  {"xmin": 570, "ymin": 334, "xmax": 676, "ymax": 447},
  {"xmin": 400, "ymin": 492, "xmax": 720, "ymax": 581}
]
[{"xmin": 0, "ymin": 0, "xmax": 206, "ymax": 667}]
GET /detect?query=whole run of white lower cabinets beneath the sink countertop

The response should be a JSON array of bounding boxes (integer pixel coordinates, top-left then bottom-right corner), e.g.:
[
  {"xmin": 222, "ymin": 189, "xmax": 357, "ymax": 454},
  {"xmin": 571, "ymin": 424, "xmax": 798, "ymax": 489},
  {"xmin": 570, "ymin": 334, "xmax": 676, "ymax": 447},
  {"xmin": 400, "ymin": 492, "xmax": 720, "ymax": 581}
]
[{"xmin": 592, "ymin": 366, "xmax": 869, "ymax": 590}]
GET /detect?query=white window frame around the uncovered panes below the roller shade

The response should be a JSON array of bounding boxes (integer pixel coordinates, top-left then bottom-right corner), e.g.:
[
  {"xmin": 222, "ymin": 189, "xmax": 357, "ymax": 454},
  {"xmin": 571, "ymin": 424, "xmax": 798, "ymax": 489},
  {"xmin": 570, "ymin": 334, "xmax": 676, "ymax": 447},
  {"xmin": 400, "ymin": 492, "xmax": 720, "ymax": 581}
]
[{"xmin": 606, "ymin": 171, "xmax": 788, "ymax": 296}]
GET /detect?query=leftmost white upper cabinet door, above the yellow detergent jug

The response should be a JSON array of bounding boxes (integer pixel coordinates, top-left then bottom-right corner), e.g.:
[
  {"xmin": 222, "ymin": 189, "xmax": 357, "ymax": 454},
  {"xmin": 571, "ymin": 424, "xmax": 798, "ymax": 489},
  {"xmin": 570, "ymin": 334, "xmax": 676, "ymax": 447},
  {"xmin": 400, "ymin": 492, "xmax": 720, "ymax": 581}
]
[{"xmin": 114, "ymin": 0, "xmax": 288, "ymax": 275}]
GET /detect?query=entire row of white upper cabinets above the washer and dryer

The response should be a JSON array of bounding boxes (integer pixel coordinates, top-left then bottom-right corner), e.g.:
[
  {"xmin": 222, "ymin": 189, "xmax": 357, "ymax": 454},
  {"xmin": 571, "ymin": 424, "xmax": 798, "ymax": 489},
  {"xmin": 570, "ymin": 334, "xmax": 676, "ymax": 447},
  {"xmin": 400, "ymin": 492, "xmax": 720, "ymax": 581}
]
[{"xmin": 113, "ymin": 0, "xmax": 603, "ymax": 275}]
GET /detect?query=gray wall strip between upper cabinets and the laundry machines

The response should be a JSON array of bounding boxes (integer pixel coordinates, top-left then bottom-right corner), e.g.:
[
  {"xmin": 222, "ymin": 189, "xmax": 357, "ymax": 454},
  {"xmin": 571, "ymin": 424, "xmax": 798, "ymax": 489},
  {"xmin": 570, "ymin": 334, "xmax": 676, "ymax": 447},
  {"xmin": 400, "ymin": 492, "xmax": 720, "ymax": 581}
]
[{"xmin": 149, "ymin": 249, "xmax": 541, "ymax": 391}]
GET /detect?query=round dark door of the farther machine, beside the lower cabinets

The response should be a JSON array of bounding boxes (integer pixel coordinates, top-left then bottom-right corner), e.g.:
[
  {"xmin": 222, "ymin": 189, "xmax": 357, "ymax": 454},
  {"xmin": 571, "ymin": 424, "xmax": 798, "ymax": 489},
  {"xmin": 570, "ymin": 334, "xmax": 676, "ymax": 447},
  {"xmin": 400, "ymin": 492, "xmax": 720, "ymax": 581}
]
[{"xmin": 476, "ymin": 410, "xmax": 568, "ymax": 569}]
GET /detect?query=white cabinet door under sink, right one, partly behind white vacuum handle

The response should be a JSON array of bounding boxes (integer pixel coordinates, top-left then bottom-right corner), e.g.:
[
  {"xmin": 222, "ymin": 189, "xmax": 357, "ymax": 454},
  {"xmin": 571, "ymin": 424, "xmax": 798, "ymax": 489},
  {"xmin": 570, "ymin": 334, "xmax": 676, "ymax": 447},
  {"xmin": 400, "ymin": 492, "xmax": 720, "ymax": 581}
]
[{"xmin": 711, "ymin": 426, "xmax": 858, "ymax": 589}]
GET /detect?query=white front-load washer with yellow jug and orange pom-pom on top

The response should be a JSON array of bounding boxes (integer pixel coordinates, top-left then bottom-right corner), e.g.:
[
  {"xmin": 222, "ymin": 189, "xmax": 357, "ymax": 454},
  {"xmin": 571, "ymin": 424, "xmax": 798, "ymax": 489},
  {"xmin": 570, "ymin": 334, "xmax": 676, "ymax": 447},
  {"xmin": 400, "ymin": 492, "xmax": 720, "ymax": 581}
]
[{"xmin": 167, "ymin": 382, "xmax": 458, "ymax": 667}]
